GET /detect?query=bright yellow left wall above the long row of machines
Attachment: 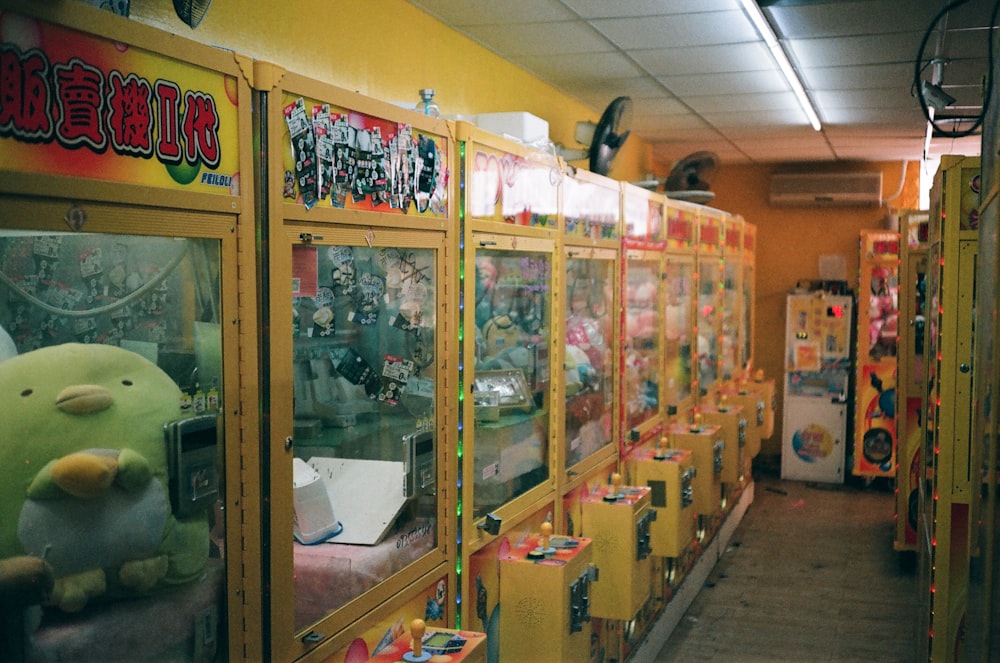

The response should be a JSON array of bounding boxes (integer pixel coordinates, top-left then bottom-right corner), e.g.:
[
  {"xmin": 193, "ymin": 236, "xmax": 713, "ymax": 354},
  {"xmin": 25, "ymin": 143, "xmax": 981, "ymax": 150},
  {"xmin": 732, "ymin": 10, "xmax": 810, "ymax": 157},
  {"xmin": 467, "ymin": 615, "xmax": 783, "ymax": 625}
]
[{"xmin": 131, "ymin": 0, "xmax": 652, "ymax": 181}]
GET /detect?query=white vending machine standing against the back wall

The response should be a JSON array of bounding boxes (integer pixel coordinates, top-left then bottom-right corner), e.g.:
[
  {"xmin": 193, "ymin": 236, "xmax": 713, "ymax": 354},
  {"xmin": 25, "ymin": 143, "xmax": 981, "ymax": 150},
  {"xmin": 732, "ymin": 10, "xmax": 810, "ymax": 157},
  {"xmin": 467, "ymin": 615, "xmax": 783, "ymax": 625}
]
[{"xmin": 781, "ymin": 290, "xmax": 854, "ymax": 483}]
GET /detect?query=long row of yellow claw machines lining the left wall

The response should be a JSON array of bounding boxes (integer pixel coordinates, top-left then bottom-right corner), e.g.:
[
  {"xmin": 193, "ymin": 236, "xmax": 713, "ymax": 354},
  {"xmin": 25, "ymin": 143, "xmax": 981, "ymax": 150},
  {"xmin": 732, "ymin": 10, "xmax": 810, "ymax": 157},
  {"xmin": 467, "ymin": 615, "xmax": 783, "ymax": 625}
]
[{"xmin": 0, "ymin": 4, "xmax": 773, "ymax": 663}]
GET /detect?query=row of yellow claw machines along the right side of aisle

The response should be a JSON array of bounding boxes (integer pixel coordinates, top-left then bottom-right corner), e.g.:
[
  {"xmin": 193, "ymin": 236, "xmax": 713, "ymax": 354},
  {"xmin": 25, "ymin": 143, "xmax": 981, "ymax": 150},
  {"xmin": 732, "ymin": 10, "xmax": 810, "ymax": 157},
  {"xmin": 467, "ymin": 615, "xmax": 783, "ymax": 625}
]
[{"xmin": 888, "ymin": 155, "xmax": 997, "ymax": 662}]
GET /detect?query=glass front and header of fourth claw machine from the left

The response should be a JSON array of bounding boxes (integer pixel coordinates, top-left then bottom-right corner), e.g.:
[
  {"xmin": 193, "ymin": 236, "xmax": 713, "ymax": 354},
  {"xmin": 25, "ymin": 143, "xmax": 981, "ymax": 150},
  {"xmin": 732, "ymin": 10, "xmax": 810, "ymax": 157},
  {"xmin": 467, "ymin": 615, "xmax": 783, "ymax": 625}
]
[{"xmin": 557, "ymin": 171, "xmax": 621, "ymax": 475}]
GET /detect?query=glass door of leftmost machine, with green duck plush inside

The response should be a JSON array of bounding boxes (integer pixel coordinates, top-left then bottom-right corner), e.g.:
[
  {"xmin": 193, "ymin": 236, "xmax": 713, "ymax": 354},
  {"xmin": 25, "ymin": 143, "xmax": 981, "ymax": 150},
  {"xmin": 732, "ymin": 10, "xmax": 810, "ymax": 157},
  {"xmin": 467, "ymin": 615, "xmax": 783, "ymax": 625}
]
[{"xmin": 0, "ymin": 204, "xmax": 239, "ymax": 661}]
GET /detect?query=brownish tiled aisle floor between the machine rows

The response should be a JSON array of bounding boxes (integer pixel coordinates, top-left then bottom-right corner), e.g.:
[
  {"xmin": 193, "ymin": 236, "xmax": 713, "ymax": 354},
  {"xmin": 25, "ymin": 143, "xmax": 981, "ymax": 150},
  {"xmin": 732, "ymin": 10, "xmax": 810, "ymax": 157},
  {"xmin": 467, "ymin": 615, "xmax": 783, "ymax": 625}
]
[{"xmin": 655, "ymin": 475, "xmax": 918, "ymax": 663}]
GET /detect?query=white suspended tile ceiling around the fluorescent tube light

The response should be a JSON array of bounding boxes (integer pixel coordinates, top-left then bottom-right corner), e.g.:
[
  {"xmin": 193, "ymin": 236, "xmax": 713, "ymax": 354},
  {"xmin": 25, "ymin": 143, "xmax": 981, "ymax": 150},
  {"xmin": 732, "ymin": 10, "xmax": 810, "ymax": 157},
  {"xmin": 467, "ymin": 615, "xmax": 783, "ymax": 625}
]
[{"xmin": 404, "ymin": 0, "xmax": 994, "ymax": 166}]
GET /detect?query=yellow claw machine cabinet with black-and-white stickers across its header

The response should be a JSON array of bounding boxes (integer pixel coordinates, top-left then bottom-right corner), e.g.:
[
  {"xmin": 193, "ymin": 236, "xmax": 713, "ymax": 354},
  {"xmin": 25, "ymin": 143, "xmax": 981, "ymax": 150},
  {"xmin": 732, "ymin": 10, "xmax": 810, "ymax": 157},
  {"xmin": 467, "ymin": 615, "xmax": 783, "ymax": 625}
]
[{"xmin": 255, "ymin": 68, "xmax": 458, "ymax": 661}]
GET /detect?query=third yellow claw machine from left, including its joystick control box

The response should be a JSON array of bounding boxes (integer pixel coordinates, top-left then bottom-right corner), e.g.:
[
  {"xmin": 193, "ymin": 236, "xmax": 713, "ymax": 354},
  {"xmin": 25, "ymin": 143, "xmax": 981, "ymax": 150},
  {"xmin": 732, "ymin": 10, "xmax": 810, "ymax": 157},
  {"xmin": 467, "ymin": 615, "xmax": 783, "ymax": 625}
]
[{"xmin": 456, "ymin": 123, "xmax": 602, "ymax": 661}]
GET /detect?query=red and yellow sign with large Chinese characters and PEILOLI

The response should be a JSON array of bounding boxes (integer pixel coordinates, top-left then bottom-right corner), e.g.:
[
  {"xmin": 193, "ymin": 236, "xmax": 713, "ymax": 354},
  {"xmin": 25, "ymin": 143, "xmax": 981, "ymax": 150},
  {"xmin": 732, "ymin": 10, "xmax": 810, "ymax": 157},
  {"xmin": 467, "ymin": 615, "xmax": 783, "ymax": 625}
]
[{"xmin": 0, "ymin": 11, "xmax": 239, "ymax": 195}]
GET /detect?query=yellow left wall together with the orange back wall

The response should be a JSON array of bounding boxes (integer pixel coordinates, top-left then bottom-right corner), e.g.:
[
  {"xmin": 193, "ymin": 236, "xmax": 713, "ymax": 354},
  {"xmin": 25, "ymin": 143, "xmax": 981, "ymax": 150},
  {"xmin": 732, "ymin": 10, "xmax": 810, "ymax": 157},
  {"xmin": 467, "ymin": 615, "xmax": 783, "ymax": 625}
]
[{"xmin": 125, "ymin": 0, "xmax": 919, "ymax": 453}]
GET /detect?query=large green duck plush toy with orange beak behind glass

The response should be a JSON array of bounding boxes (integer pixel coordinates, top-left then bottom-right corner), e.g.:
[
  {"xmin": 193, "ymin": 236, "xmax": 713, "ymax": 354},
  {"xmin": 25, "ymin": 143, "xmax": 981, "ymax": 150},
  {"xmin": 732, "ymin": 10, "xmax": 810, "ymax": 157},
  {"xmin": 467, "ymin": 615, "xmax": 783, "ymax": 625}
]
[{"xmin": 0, "ymin": 343, "xmax": 209, "ymax": 612}]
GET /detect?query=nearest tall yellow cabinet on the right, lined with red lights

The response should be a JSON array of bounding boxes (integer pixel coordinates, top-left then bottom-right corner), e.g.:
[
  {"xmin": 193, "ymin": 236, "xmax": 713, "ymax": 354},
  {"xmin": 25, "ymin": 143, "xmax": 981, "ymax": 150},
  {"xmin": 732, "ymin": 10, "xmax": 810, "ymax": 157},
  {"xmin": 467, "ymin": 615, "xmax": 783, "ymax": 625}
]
[{"xmin": 917, "ymin": 155, "xmax": 981, "ymax": 661}]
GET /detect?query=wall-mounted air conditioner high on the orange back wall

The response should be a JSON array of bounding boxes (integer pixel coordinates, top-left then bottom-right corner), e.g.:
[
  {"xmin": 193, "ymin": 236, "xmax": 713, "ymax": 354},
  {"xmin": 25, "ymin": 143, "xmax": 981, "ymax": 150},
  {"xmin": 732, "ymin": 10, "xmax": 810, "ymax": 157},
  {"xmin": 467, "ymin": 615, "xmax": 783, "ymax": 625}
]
[{"xmin": 770, "ymin": 171, "xmax": 882, "ymax": 207}]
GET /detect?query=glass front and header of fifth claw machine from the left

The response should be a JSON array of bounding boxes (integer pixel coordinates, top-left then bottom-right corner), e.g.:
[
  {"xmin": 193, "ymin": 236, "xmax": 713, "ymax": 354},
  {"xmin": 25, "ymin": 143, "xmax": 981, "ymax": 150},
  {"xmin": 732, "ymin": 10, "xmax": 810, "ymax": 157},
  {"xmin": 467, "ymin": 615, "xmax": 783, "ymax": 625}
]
[{"xmin": 619, "ymin": 183, "xmax": 665, "ymax": 458}]
